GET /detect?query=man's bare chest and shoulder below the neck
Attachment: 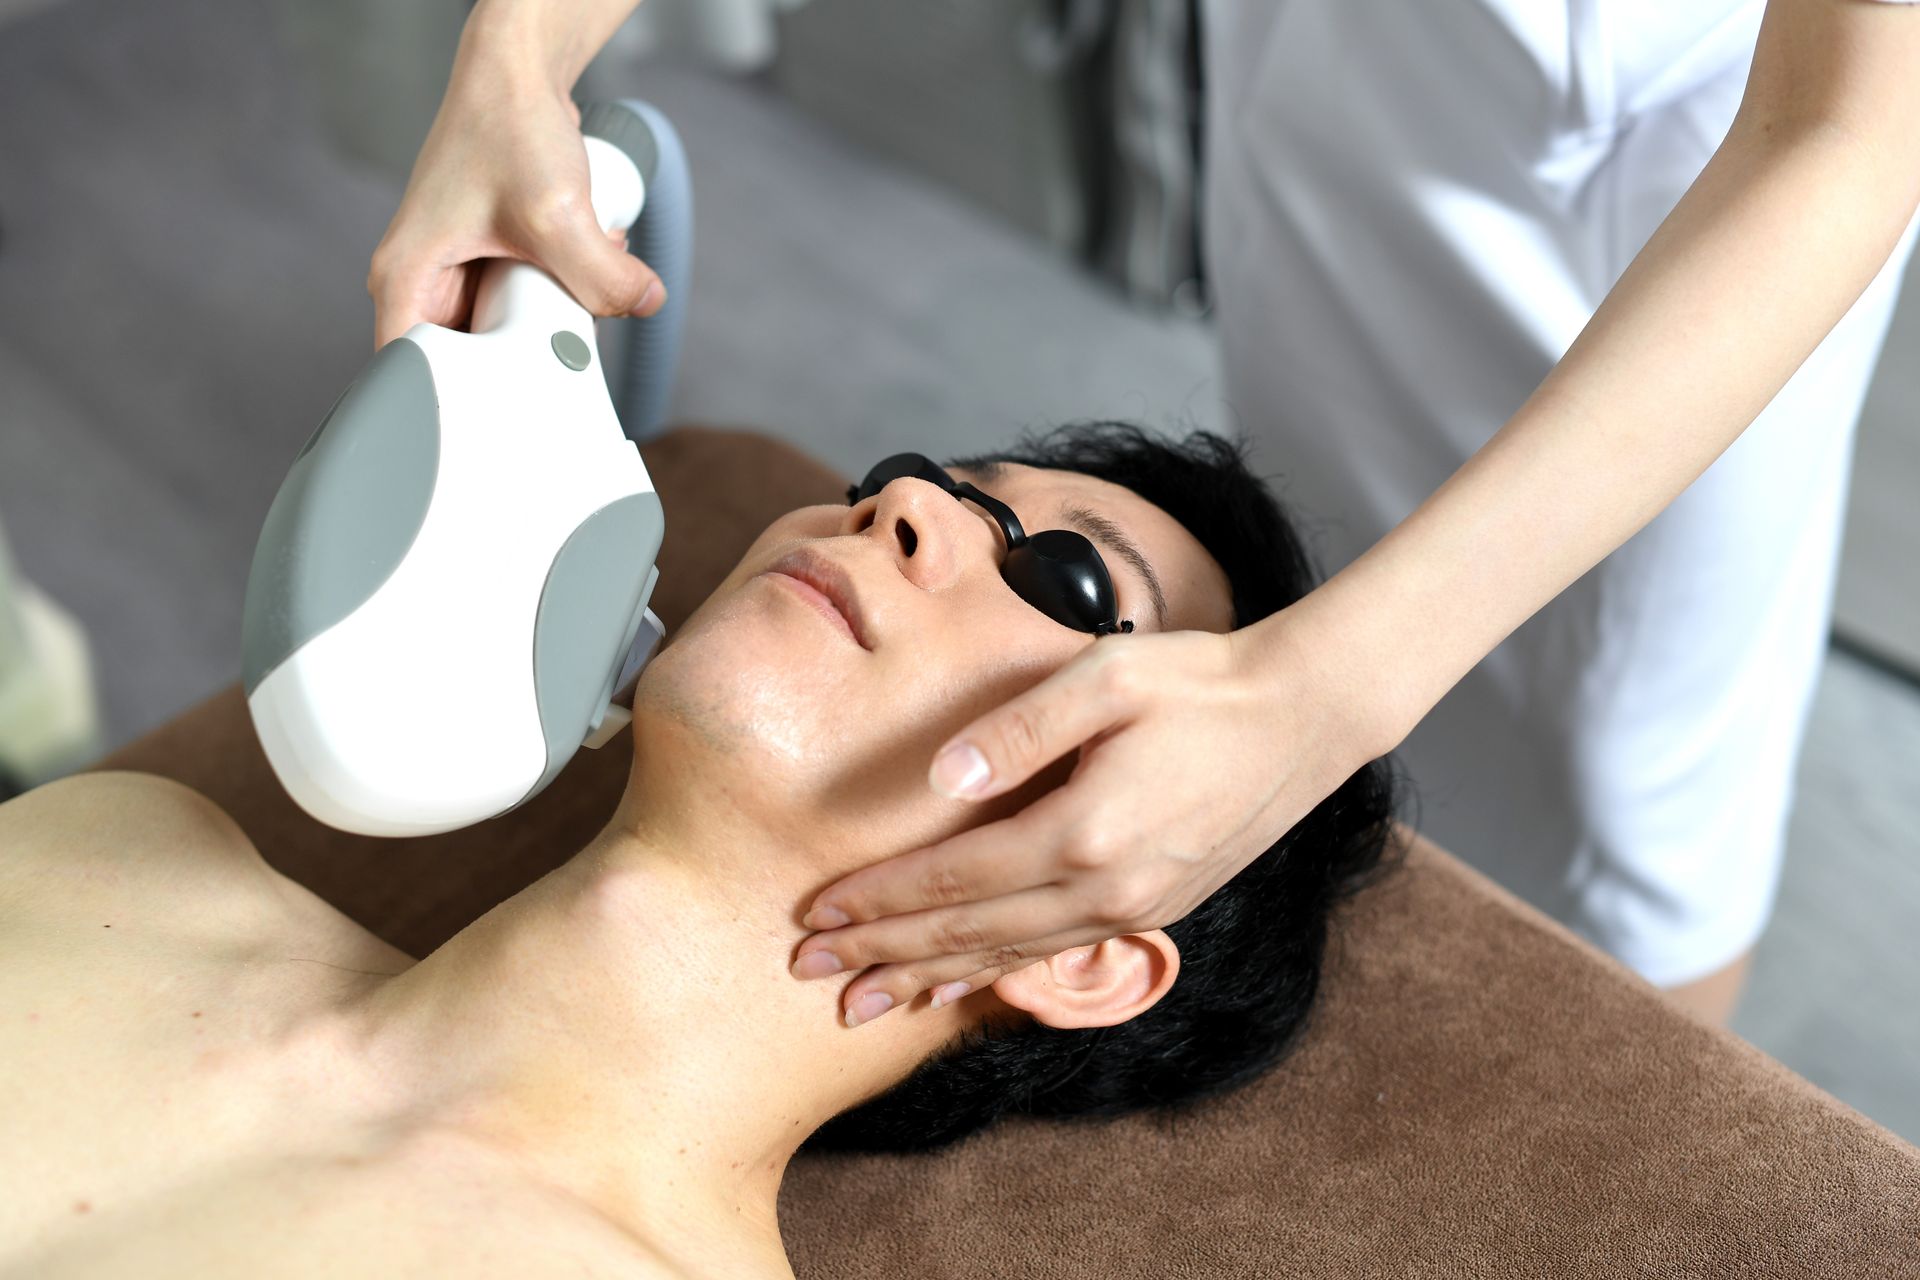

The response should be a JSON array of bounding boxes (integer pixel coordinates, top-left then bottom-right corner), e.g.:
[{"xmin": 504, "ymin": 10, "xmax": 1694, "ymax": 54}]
[{"xmin": 0, "ymin": 775, "xmax": 668, "ymax": 1280}]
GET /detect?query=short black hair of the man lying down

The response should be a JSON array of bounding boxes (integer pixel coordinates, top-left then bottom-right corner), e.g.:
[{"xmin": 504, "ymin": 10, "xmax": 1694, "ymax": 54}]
[{"xmin": 806, "ymin": 422, "xmax": 1394, "ymax": 1151}]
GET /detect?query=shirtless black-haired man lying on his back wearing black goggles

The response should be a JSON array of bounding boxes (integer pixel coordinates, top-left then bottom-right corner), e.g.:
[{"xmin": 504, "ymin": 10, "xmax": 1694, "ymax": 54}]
[{"xmin": 0, "ymin": 424, "xmax": 1390, "ymax": 1280}]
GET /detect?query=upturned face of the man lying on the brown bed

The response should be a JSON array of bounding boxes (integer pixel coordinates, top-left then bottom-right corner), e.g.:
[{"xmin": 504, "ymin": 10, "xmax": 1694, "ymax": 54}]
[{"xmin": 634, "ymin": 464, "xmax": 1233, "ymax": 869}]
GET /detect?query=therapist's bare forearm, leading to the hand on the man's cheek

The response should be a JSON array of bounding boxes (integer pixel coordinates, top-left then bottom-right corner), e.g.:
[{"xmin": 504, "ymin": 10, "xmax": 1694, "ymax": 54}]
[{"xmin": 1259, "ymin": 92, "xmax": 1920, "ymax": 750}]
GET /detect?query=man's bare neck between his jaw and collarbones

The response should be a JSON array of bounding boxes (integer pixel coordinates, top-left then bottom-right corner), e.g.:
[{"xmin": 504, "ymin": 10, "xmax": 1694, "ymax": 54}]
[{"xmin": 345, "ymin": 791, "xmax": 964, "ymax": 1274}]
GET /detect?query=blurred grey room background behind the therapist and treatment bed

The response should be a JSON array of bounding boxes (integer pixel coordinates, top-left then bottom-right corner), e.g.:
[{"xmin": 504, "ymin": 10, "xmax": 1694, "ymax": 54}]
[{"xmin": 0, "ymin": 0, "xmax": 1920, "ymax": 1140}]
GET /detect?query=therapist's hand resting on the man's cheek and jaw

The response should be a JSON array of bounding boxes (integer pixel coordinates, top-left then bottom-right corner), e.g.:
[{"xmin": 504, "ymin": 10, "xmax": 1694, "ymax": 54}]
[{"xmin": 793, "ymin": 610, "xmax": 1384, "ymax": 1025}]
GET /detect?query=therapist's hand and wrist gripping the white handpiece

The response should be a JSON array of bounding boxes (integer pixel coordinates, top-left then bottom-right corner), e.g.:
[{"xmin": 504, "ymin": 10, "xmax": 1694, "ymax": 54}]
[{"xmin": 367, "ymin": 0, "xmax": 666, "ymax": 349}]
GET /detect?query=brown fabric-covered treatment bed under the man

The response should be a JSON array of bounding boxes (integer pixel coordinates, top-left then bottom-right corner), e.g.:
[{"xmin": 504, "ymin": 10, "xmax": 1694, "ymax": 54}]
[{"xmin": 100, "ymin": 428, "xmax": 1920, "ymax": 1280}]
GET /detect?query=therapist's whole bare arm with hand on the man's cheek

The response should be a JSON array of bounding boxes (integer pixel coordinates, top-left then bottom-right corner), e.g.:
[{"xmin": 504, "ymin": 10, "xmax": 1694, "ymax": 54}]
[{"xmin": 797, "ymin": 0, "xmax": 1920, "ymax": 1023}]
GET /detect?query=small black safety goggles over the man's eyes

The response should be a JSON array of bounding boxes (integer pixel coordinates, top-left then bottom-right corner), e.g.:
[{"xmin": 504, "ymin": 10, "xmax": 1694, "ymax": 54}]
[{"xmin": 847, "ymin": 453, "xmax": 1133, "ymax": 635}]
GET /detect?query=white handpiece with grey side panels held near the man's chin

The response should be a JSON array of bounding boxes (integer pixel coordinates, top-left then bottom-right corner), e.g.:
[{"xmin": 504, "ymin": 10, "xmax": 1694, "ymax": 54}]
[{"xmin": 248, "ymin": 119, "xmax": 664, "ymax": 835}]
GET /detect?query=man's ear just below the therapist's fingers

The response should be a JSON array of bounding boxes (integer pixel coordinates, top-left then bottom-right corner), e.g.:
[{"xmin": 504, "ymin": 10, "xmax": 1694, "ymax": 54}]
[{"xmin": 993, "ymin": 929, "xmax": 1181, "ymax": 1031}]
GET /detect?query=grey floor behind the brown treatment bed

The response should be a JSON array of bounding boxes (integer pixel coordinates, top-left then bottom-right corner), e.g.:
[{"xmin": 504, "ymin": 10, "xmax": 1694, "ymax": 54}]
[{"xmin": 0, "ymin": 0, "xmax": 1920, "ymax": 1138}]
